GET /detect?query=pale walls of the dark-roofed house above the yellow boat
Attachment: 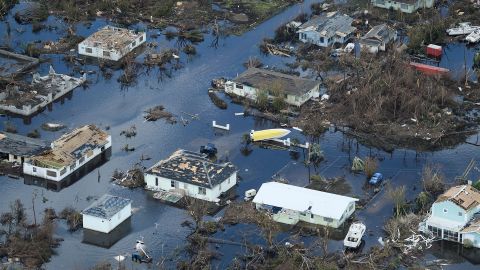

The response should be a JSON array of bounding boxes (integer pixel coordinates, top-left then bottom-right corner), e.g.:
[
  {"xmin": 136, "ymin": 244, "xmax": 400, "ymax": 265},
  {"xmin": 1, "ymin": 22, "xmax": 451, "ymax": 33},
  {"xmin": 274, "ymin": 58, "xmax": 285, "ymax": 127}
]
[{"xmin": 225, "ymin": 81, "xmax": 320, "ymax": 107}]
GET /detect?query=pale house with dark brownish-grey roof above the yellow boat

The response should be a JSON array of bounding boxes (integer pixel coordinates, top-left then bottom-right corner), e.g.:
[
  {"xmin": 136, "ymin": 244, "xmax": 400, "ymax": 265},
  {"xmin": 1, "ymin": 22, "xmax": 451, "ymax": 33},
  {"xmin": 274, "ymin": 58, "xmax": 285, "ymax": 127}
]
[{"xmin": 225, "ymin": 68, "xmax": 320, "ymax": 106}]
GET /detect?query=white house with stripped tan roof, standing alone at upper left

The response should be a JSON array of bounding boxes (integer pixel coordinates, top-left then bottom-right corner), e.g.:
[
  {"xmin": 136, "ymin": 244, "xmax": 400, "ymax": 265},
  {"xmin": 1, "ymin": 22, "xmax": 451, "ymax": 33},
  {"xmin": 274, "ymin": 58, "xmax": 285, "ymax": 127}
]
[{"xmin": 78, "ymin": 25, "xmax": 147, "ymax": 61}]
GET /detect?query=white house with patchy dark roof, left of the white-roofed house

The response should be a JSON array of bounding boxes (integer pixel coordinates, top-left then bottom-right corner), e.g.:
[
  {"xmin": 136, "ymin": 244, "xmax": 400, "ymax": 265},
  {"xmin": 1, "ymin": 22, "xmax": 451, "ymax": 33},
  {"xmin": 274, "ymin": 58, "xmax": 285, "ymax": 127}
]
[{"xmin": 145, "ymin": 150, "xmax": 237, "ymax": 202}]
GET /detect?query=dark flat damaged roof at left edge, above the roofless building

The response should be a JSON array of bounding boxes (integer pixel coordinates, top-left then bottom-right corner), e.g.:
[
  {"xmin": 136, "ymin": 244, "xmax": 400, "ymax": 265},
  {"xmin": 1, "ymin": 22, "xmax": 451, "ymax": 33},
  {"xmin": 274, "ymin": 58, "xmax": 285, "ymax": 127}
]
[{"xmin": 0, "ymin": 50, "xmax": 39, "ymax": 79}]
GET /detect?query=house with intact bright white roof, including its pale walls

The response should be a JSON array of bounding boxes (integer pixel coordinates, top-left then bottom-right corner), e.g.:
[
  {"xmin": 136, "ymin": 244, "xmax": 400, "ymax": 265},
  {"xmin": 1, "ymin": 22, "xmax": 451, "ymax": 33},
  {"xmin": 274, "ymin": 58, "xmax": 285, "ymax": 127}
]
[{"xmin": 253, "ymin": 182, "xmax": 358, "ymax": 228}]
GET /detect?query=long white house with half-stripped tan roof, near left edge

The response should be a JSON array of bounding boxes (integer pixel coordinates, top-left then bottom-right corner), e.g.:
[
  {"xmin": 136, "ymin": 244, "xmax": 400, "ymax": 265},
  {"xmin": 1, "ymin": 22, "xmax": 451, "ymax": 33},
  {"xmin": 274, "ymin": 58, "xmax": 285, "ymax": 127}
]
[{"xmin": 23, "ymin": 125, "xmax": 112, "ymax": 190}]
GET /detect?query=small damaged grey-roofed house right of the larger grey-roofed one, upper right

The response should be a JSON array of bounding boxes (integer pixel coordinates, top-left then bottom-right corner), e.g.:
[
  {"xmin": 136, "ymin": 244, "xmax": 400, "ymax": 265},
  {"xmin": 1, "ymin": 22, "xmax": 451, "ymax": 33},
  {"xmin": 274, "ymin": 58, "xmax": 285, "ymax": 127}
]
[{"xmin": 359, "ymin": 24, "xmax": 397, "ymax": 53}]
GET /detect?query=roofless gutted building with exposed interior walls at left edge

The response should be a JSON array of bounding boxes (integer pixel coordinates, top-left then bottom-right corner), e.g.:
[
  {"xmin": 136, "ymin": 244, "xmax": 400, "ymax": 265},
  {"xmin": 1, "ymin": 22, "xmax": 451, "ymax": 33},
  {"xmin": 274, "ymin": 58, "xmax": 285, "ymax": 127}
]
[{"xmin": 0, "ymin": 67, "xmax": 86, "ymax": 116}]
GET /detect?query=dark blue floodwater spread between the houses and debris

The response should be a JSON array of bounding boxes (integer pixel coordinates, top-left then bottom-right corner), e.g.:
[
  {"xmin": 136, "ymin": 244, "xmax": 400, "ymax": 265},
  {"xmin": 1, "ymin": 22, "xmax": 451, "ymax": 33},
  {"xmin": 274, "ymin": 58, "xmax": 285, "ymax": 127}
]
[{"xmin": 0, "ymin": 1, "xmax": 479, "ymax": 269}]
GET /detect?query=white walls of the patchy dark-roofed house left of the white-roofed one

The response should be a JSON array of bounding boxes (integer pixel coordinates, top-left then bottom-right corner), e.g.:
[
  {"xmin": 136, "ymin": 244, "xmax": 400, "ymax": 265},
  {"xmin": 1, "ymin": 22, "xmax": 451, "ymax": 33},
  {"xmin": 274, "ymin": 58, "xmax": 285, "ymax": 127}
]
[{"xmin": 145, "ymin": 172, "xmax": 237, "ymax": 202}]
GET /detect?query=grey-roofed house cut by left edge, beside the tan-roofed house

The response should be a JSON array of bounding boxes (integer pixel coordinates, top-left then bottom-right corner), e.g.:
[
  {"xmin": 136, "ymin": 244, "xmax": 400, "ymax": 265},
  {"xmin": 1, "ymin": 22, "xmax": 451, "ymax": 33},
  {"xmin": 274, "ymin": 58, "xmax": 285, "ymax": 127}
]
[{"xmin": 0, "ymin": 132, "xmax": 50, "ymax": 164}]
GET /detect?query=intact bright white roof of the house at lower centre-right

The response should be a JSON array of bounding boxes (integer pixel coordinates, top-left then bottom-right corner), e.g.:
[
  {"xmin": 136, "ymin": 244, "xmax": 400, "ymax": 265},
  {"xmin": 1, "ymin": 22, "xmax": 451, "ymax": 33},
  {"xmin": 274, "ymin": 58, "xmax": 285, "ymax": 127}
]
[{"xmin": 253, "ymin": 182, "xmax": 358, "ymax": 219}]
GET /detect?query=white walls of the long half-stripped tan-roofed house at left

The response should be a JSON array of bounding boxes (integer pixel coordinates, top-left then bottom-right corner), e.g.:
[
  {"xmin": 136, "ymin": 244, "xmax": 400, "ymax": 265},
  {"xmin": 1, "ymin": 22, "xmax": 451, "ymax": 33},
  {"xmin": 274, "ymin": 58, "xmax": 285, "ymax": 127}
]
[{"xmin": 23, "ymin": 135, "xmax": 112, "ymax": 182}]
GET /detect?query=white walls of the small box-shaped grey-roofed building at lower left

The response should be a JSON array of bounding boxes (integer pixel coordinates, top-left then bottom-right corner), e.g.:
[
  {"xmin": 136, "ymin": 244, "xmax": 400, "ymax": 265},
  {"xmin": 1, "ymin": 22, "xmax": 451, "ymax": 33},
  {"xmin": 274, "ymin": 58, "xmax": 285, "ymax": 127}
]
[{"xmin": 83, "ymin": 203, "xmax": 132, "ymax": 233}]
